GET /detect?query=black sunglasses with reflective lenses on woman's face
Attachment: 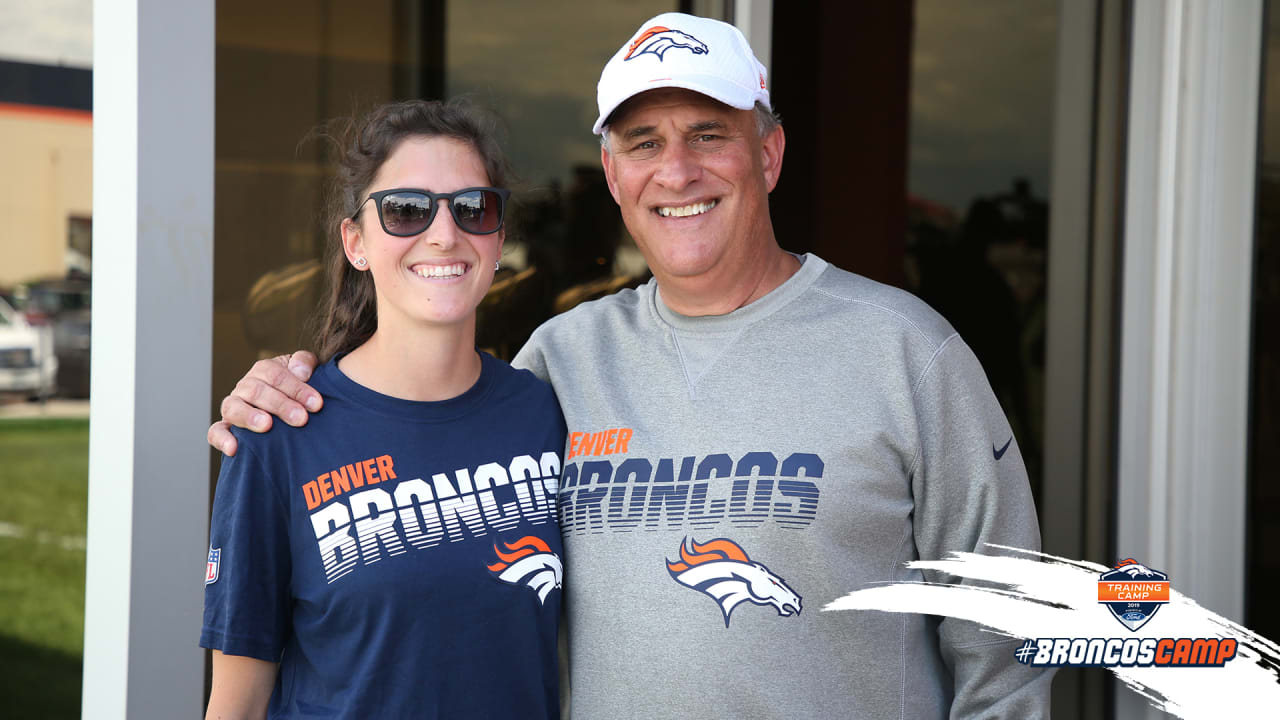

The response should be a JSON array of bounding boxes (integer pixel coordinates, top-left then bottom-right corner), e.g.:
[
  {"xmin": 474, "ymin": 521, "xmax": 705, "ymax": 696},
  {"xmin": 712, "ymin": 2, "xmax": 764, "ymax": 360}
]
[{"xmin": 351, "ymin": 187, "xmax": 511, "ymax": 237}]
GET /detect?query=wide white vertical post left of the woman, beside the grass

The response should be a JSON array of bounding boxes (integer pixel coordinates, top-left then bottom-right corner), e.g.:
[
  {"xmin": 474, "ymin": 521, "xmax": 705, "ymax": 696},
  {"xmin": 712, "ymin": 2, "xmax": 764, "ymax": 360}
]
[{"xmin": 82, "ymin": 0, "xmax": 215, "ymax": 719}]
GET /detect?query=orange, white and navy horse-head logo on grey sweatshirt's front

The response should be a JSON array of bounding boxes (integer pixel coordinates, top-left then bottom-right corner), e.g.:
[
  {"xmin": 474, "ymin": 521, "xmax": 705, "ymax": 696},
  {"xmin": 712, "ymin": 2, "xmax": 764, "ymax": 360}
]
[{"xmin": 667, "ymin": 537, "xmax": 800, "ymax": 628}]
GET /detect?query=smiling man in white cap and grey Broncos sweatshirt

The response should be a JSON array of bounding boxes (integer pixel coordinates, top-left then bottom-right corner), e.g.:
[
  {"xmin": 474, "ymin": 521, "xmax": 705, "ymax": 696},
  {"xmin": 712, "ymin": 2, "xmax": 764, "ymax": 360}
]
[{"xmin": 210, "ymin": 13, "xmax": 1051, "ymax": 719}]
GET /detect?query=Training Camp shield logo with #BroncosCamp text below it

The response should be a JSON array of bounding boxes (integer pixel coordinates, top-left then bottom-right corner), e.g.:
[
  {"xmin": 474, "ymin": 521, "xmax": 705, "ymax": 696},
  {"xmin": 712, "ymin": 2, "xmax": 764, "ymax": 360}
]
[{"xmin": 1014, "ymin": 557, "xmax": 1236, "ymax": 667}]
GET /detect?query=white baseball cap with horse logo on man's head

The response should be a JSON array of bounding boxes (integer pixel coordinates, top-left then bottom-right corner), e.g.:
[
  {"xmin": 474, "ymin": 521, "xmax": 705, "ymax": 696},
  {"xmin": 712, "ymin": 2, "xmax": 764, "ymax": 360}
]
[{"xmin": 591, "ymin": 13, "xmax": 773, "ymax": 135}]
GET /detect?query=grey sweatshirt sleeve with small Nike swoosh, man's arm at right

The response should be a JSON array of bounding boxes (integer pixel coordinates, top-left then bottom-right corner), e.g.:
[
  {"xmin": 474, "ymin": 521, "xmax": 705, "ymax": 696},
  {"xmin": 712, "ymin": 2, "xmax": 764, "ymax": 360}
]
[{"xmin": 911, "ymin": 334, "xmax": 1053, "ymax": 719}]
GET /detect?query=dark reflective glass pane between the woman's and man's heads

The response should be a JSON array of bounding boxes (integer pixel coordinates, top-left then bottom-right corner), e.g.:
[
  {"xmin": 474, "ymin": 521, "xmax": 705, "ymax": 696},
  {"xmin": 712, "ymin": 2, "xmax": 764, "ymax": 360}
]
[{"xmin": 444, "ymin": 0, "xmax": 677, "ymax": 357}]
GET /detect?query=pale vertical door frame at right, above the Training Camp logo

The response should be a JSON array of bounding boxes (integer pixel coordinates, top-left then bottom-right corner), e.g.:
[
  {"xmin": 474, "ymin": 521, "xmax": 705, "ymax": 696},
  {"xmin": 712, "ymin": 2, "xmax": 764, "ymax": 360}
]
[{"xmin": 1116, "ymin": 0, "xmax": 1263, "ymax": 717}]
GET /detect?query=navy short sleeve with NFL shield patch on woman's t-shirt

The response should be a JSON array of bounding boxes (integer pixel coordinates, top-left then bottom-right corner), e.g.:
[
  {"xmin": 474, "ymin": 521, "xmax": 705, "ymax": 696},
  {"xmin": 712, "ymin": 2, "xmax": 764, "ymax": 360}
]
[{"xmin": 200, "ymin": 437, "xmax": 292, "ymax": 662}]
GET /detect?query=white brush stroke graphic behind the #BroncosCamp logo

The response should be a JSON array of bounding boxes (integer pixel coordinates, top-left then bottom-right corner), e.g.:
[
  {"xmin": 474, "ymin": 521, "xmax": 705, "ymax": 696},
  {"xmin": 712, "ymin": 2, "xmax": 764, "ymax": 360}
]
[{"xmin": 822, "ymin": 546, "xmax": 1280, "ymax": 720}]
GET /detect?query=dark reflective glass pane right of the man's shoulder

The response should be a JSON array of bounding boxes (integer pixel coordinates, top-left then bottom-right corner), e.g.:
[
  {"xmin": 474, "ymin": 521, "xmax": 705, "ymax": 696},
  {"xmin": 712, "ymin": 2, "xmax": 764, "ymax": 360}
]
[{"xmin": 906, "ymin": 0, "xmax": 1057, "ymax": 504}]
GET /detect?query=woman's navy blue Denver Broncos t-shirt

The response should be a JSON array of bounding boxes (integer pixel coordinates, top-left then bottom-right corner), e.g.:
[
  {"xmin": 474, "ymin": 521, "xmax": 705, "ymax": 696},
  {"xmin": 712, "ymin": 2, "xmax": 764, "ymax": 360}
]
[{"xmin": 200, "ymin": 355, "xmax": 564, "ymax": 719}]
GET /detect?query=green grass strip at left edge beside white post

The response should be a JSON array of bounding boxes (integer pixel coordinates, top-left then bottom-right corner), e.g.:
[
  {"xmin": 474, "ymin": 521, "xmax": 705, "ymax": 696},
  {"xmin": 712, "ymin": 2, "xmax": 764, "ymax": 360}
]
[{"xmin": 0, "ymin": 420, "xmax": 88, "ymax": 719}]
